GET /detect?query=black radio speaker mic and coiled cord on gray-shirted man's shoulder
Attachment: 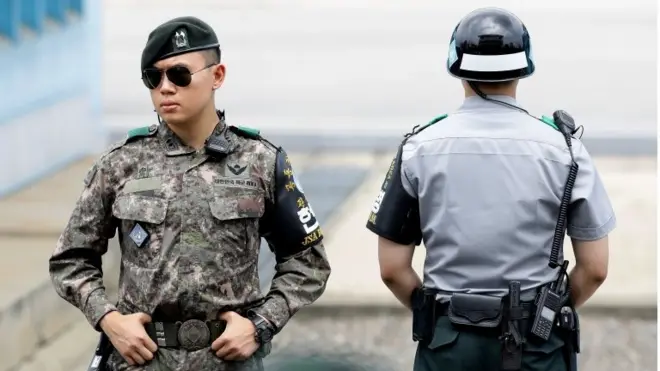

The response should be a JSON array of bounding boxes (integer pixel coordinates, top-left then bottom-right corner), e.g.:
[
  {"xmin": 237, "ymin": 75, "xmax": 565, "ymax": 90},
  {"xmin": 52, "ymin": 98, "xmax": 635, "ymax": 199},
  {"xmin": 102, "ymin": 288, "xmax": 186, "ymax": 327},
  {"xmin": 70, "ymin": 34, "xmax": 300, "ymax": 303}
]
[{"xmin": 542, "ymin": 111, "xmax": 579, "ymax": 269}]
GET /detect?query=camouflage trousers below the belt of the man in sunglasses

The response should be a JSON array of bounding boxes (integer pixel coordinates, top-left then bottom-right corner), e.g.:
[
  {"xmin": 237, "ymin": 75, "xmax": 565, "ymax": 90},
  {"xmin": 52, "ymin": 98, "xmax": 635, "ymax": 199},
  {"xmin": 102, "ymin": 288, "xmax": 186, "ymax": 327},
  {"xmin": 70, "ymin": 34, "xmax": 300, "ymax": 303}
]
[{"xmin": 106, "ymin": 348, "xmax": 263, "ymax": 371}]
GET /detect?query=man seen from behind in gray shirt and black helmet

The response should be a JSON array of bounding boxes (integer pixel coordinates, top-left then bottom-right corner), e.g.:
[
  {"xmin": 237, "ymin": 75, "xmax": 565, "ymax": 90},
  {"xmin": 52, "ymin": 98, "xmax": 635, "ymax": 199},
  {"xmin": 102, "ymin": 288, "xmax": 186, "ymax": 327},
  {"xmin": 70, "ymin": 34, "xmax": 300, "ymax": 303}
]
[{"xmin": 367, "ymin": 8, "xmax": 616, "ymax": 371}]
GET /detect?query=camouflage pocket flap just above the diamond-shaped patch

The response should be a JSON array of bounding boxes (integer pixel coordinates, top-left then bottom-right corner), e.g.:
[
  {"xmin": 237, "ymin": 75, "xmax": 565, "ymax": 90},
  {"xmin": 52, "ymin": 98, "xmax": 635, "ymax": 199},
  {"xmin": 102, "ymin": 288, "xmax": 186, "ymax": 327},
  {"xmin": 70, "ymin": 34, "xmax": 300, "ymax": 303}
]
[{"xmin": 112, "ymin": 194, "xmax": 167, "ymax": 224}]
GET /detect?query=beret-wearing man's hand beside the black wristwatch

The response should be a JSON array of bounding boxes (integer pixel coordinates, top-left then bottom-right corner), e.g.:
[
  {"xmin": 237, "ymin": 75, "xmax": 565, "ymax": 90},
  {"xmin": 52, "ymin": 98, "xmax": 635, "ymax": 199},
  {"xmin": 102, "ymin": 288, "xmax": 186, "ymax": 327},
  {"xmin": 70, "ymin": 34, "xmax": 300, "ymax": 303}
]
[{"xmin": 211, "ymin": 312, "xmax": 259, "ymax": 361}]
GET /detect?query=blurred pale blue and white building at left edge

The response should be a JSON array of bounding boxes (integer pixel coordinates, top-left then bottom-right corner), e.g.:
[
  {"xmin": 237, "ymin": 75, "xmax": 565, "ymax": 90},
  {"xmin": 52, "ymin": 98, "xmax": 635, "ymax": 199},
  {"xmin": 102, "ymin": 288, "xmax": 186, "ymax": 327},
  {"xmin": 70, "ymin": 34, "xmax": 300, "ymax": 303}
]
[{"xmin": 0, "ymin": 0, "xmax": 103, "ymax": 197}]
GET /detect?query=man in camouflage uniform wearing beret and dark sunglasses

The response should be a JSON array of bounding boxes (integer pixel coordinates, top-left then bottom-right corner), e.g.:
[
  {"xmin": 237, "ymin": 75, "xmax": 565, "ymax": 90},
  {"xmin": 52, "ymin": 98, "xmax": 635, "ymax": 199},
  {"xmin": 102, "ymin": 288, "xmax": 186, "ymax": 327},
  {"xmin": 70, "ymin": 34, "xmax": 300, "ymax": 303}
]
[{"xmin": 50, "ymin": 17, "xmax": 330, "ymax": 371}]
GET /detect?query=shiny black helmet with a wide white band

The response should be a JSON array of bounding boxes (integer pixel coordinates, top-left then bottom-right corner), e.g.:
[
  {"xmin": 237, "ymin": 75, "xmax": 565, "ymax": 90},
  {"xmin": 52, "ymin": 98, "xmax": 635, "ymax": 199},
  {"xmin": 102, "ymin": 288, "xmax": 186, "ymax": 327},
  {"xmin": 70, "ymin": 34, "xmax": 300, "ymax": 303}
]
[{"xmin": 447, "ymin": 8, "xmax": 535, "ymax": 82}]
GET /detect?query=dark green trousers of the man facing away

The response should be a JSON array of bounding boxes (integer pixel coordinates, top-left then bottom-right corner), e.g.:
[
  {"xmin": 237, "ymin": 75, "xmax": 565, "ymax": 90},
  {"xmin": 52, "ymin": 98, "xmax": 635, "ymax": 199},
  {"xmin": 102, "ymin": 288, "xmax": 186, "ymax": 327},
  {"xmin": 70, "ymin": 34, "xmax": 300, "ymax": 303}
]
[{"xmin": 413, "ymin": 317, "xmax": 567, "ymax": 371}]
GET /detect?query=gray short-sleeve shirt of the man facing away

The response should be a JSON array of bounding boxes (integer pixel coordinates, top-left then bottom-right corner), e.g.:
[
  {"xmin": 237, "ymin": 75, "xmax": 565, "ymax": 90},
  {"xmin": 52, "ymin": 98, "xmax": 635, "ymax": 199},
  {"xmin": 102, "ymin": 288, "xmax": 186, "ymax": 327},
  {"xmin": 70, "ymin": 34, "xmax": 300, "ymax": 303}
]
[{"xmin": 401, "ymin": 96, "xmax": 615, "ymax": 300}]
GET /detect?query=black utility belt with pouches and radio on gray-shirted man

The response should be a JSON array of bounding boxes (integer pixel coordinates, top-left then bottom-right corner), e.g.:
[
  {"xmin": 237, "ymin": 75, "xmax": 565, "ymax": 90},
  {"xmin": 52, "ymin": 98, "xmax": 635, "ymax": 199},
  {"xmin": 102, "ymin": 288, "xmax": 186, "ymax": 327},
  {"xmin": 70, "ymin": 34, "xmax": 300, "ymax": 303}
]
[{"xmin": 412, "ymin": 282, "xmax": 579, "ymax": 371}]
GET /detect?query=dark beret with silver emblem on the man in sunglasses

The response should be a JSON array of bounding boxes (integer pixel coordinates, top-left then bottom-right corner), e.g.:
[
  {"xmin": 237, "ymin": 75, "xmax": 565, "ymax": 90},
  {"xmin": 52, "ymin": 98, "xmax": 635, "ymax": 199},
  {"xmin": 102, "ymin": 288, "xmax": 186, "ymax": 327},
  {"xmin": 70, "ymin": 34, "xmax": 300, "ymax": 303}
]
[{"xmin": 140, "ymin": 17, "xmax": 220, "ymax": 71}]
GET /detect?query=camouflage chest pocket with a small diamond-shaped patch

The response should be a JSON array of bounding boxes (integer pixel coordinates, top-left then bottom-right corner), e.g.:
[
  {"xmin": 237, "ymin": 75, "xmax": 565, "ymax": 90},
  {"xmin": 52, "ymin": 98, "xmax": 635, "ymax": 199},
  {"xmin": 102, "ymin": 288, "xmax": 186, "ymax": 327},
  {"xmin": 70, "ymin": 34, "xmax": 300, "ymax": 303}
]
[{"xmin": 112, "ymin": 194, "xmax": 168, "ymax": 266}]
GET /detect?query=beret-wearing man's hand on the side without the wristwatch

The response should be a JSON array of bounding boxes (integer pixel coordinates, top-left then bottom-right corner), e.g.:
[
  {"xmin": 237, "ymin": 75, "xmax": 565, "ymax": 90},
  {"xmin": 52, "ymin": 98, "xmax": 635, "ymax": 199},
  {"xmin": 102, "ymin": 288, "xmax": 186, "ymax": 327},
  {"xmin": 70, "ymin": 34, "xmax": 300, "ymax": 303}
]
[{"xmin": 101, "ymin": 312, "xmax": 158, "ymax": 366}]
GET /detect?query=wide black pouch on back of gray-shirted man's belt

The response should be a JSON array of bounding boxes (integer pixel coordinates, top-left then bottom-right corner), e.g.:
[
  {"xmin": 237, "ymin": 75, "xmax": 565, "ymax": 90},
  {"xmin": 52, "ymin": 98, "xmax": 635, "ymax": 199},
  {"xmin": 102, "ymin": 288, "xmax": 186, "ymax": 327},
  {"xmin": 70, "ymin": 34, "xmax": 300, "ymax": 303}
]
[{"xmin": 449, "ymin": 294, "xmax": 504, "ymax": 328}]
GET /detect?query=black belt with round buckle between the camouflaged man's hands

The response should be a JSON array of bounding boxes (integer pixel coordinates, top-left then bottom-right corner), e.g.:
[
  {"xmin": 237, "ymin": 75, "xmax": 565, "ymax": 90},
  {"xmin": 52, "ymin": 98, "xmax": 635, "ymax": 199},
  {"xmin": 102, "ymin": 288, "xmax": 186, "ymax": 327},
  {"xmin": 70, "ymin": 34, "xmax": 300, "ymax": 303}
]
[{"xmin": 144, "ymin": 319, "xmax": 227, "ymax": 351}]
